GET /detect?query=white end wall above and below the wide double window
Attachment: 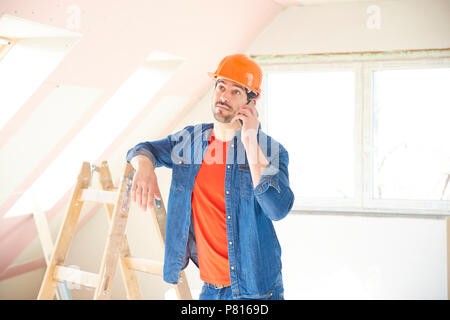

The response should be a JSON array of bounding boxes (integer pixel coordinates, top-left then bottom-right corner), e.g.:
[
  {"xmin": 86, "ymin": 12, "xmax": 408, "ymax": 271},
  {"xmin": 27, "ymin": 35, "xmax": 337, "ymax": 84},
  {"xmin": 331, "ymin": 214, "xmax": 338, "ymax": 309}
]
[{"xmin": 243, "ymin": 0, "xmax": 450, "ymax": 299}]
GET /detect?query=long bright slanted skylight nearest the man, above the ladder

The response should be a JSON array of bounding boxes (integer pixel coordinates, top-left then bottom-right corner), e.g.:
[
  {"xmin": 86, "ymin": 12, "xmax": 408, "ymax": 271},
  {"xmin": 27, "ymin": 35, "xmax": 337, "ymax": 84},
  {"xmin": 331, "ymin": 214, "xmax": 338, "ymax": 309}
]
[{"xmin": 5, "ymin": 52, "xmax": 185, "ymax": 218}]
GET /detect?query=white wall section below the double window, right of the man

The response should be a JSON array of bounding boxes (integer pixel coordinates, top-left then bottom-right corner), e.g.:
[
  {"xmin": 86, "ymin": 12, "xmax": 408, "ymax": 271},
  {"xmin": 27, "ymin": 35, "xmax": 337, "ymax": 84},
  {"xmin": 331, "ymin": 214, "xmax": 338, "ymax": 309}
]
[{"xmin": 275, "ymin": 212, "xmax": 447, "ymax": 299}]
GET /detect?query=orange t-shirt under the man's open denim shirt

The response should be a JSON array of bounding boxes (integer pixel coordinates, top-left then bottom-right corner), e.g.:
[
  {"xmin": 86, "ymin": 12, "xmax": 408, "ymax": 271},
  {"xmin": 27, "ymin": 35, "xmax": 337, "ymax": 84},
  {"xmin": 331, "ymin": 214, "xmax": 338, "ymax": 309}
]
[{"xmin": 191, "ymin": 133, "xmax": 231, "ymax": 286}]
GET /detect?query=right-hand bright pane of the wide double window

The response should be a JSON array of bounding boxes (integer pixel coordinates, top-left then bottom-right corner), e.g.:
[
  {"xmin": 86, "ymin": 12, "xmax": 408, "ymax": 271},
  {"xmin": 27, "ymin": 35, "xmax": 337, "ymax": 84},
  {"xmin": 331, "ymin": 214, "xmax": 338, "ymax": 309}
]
[{"xmin": 372, "ymin": 68, "xmax": 450, "ymax": 200}]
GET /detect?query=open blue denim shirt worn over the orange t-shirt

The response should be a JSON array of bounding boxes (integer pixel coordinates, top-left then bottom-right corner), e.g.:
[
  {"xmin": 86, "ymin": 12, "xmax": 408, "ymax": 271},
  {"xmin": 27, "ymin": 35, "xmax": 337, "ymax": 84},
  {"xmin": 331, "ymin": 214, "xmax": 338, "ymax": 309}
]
[{"xmin": 126, "ymin": 123, "xmax": 294, "ymax": 299}]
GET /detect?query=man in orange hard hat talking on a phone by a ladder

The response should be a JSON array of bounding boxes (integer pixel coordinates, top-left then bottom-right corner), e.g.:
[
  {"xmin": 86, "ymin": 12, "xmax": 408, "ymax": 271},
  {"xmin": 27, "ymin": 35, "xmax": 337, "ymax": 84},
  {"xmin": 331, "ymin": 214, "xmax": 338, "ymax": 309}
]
[{"xmin": 127, "ymin": 54, "xmax": 294, "ymax": 299}]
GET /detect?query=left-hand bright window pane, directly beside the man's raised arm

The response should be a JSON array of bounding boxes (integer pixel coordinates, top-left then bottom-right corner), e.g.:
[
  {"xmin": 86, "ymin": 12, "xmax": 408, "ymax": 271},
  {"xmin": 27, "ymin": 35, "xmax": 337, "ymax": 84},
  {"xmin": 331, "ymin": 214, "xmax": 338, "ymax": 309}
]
[{"xmin": 267, "ymin": 70, "xmax": 355, "ymax": 199}]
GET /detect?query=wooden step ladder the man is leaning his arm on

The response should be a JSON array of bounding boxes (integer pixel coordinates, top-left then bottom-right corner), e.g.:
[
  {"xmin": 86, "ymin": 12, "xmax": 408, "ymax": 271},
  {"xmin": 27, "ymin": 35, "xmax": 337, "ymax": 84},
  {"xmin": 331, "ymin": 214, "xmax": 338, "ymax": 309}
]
[{"xmin": 38, "ymin": 161, "xmax": 192, "ymax": 300}]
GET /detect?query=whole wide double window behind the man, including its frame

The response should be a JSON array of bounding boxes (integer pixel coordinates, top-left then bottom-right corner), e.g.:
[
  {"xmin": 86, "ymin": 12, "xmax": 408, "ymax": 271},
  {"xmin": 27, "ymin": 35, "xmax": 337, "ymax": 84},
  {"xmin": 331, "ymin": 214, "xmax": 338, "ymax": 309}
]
[{"xmin": 256, "ymin": 50, "xmax": 450, "ymax": 215}]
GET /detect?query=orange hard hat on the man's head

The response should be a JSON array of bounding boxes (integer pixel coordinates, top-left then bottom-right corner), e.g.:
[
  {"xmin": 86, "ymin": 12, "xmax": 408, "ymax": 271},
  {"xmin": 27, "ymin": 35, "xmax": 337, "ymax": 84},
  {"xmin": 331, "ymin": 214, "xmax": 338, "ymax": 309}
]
[{"xmin": 208, "ymin": 53, "xmax": 262, "ymax": 94}]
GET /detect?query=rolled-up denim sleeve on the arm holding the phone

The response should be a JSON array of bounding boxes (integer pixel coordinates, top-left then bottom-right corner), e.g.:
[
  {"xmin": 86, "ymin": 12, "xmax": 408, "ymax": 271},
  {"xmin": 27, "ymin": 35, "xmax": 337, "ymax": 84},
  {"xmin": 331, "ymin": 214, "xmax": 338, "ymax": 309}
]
[{"xmin": 253, "ymin": 150, "xmax": 294, "ymax": 220}]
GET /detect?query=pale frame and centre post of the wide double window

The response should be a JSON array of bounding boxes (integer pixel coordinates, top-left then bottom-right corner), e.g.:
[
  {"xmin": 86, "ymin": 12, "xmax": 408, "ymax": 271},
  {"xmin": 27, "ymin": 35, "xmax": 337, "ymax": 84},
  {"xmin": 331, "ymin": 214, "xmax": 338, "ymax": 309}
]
[{"xmin": 253, "ymin": 49, "xmax": 450, "ymax": 217}]
